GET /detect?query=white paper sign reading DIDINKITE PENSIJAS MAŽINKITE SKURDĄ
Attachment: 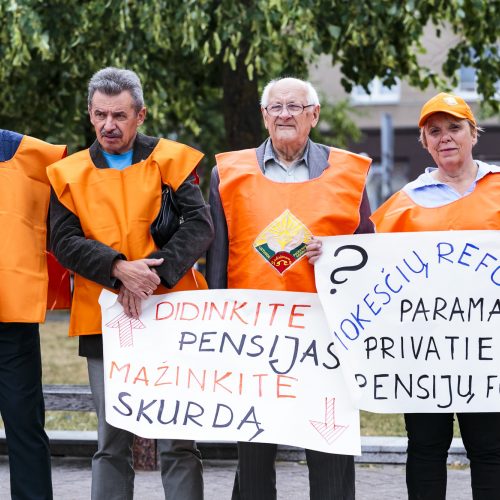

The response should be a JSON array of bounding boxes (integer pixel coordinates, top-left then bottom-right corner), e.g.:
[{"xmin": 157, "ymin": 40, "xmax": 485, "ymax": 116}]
[{"xmin": 100, "ymin": 290, "xmax": 361, "ymax": 455}]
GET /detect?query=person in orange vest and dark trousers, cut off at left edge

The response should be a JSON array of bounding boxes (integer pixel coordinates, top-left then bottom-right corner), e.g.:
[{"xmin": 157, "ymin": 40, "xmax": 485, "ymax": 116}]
[{"xmin": 0, "ymin": 129, "xmax": 66, "ymax": 500}]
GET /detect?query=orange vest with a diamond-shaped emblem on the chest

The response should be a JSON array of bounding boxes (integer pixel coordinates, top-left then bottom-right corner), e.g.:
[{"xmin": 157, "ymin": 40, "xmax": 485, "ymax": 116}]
[{"xmin": 216, "ymin": 148, "xmax": 371, "ymax": 292}]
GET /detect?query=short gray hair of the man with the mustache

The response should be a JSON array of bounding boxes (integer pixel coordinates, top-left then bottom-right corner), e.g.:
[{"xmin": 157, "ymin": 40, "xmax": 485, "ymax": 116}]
[{"xmin": 88, "ymin": 66, "xmax": 144, "ymax": 113}]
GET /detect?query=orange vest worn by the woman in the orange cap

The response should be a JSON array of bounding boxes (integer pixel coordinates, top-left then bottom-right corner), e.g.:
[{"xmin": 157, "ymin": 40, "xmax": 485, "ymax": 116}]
[{"xmin": 370, "ymin": 173, "xmax": 500, "ymax": 233}]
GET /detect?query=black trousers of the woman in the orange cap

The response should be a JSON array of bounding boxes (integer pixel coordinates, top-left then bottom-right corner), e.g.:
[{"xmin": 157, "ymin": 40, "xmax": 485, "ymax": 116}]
[{"xmin": 405, "ymin": 413, "xmax": 500, "ymax": 500}]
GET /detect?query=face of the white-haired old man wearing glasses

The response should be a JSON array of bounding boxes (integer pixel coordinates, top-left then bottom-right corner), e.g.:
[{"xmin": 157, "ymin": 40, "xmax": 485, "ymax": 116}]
[{"xmin": 262, "ymin": 80, "xmax": 319, "ymax": 150}]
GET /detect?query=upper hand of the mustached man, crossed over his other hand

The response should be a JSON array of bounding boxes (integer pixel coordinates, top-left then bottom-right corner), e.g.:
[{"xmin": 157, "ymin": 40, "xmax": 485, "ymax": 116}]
[{"xmin": 111, "ymin": 259, "xmax": 163, "ymax": 299}]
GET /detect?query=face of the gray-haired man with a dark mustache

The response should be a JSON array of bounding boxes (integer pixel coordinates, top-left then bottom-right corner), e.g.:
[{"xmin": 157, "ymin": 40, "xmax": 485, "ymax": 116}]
[{"xmin": 89, "ymin": 91, "xmax": 146, "ymax": 154}]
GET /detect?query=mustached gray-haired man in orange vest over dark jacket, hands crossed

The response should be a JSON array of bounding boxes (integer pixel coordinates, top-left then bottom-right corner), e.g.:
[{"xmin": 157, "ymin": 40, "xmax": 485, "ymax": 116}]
[{"xmin": 49, "ymin": 68, "xmax": 213, "ymax": 500}]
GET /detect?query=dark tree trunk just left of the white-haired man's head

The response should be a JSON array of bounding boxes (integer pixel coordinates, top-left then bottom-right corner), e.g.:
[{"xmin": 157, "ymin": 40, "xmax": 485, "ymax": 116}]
[{"xmin": 222, "ymin": 48, "xmax": 264, "ymax": 151}]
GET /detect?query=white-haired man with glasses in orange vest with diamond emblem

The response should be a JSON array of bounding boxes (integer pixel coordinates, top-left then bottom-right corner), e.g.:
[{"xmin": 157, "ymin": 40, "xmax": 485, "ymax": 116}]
[{"xmin": 207, "ymin": 78, "xmax": 373, "ymax": 500}]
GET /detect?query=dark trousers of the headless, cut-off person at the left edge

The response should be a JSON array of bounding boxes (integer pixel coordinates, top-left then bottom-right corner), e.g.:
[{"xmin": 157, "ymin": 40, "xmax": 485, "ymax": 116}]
[{"xmin": 0, "ymin": 323, "xmax": 52, "ymax": 500}]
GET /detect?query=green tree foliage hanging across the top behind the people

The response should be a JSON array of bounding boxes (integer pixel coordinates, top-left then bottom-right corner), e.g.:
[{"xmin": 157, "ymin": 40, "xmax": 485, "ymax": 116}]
[{"xmin": 0, "ymin": 0, "xmax": 500, "ymax": 179}]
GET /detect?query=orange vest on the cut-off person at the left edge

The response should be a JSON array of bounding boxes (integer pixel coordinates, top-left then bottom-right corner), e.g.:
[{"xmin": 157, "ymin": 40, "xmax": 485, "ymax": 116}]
[{"xmin": 0, "ymin": 135, "xmax": 66, "ymax": 323}]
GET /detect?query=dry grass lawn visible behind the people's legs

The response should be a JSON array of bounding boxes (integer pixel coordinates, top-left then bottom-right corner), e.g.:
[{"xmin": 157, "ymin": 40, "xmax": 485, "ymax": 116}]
[{"xmin": 32, "ymin": 312, "xmax": 460, "ymax": 436}]
